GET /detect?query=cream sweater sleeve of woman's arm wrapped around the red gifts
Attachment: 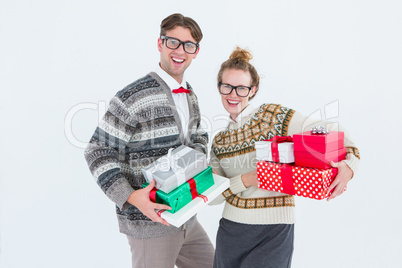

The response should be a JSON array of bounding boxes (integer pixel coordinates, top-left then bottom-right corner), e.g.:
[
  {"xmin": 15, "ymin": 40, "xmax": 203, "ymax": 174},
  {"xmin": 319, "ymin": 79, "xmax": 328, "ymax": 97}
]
[{"xmin": 285, "ymin": 112, "xmax": 360, "ymax": 174}]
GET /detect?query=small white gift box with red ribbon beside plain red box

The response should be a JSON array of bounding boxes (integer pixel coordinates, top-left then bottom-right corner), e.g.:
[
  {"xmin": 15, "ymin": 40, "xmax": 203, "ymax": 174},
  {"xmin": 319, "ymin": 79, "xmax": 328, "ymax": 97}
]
[{"xmin": 255, "ymin": 136, "xmax": 295, "ymax": 163}]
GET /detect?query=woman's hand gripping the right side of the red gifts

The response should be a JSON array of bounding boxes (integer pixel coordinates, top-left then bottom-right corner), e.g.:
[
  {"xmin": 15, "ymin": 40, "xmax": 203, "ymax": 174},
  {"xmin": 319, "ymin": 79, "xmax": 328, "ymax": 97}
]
[{"xmin": 327, "ymin": 161, "xmax": 353, "ymax": 201}]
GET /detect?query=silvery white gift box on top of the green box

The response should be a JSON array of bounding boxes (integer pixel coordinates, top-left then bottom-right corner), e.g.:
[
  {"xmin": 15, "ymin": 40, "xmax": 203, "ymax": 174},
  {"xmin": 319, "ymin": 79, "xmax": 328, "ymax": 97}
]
[{"xmin": 142, "ymin": 145, "xmax": 208, "ymax": 193}]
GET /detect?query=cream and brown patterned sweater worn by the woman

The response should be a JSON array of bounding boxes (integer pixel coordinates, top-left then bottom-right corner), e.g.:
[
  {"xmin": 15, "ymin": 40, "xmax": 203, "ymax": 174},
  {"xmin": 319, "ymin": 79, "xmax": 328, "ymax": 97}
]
[{"xmin": 210, "ymin": 104, "xmax": 360, "ymax": 224}]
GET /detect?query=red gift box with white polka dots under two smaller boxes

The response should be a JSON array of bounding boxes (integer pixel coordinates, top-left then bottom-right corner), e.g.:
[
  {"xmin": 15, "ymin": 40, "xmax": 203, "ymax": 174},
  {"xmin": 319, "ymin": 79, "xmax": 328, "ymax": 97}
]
[{"xmin": 257, "ymin": 161, "xmax": 346, "ymax": 200}]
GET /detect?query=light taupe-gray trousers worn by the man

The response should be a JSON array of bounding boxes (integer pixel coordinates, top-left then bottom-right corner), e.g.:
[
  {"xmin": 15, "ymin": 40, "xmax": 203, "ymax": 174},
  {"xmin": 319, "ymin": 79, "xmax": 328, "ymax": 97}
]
[{"xmin": 127, "ymin": 221, "xmax": 214, "ymax": 268}]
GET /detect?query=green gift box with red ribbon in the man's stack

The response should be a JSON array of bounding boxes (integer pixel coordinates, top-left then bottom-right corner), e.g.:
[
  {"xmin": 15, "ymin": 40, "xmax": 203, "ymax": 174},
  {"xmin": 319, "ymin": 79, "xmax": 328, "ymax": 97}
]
[{"xmin": 142, "ymin": 166, "xmax": 214, "ymax": 213}]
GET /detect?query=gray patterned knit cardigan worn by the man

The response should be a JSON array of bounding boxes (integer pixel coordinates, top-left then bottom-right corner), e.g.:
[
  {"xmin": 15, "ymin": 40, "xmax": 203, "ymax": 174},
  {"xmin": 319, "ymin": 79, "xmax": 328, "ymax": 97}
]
[{"xmin": 85, "ymin": 73, "xmax": 208, "ymax": 238}]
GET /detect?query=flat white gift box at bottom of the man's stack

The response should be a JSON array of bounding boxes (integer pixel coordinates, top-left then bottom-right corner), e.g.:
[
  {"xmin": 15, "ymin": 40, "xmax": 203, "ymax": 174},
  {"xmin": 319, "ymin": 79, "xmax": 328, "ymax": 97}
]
[{"xmin": 160, "ymin": 174, "xmax": 230, "ymax": 227}]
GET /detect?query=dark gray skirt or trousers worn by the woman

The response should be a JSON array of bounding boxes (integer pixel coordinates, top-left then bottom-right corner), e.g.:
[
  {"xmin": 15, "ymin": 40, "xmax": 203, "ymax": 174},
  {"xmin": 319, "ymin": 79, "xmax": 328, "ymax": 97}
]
[{"xmin": 214, "ymin": 218, "xmax": 294, "ymax": 268}]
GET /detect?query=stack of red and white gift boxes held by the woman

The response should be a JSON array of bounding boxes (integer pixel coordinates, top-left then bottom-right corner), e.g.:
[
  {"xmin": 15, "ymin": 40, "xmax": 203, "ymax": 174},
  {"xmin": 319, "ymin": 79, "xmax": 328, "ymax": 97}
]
[{"xmin": 255, "ymin": 127, "xmax": 346, "ymax": 200}]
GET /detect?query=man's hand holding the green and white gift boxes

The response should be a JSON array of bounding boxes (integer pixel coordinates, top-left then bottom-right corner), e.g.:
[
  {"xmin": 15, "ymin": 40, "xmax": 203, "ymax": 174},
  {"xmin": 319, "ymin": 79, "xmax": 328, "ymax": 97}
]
[{"xmin": 127, "ymin": 180, "xmax": 171, "ymax": 226}]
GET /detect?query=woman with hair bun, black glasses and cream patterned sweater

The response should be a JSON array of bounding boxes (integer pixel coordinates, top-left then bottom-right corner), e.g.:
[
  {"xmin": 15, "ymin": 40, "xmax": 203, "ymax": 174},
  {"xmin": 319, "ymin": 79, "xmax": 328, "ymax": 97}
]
[{"xmin": 210, "ymin": 48, "xmax": 359, "ymax": 268}]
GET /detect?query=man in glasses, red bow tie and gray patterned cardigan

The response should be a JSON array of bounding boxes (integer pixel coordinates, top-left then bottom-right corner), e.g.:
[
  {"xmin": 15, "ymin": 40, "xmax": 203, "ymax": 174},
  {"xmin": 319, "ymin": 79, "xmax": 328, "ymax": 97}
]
[{"xmin": 85, "ymin": 14, "xmax": 214, "ymax": 267}]
